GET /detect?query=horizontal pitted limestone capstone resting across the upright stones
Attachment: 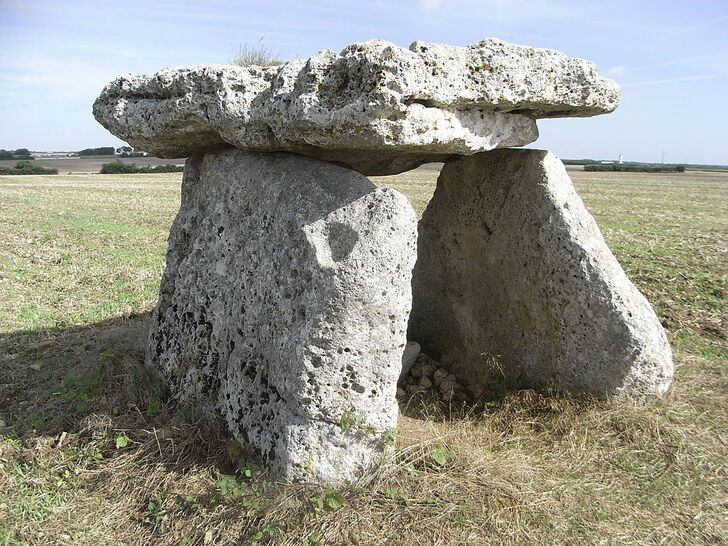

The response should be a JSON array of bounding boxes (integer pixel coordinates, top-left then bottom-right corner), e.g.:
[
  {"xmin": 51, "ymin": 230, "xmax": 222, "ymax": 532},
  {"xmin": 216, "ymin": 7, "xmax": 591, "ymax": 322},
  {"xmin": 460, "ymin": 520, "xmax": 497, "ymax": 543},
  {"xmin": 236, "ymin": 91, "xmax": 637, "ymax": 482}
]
[{"xmin": 94, "ymin": 38, "xmax": 619, "ymax": 175}]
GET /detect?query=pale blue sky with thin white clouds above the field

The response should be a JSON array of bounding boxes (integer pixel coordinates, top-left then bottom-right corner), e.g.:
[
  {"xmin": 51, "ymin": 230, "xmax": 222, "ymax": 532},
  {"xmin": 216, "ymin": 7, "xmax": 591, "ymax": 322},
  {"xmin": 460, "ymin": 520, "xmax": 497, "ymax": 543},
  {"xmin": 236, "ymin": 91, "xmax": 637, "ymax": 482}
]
[{"xmin": 0, "ymin": 0, "xmax": 728, "ymax": 164}]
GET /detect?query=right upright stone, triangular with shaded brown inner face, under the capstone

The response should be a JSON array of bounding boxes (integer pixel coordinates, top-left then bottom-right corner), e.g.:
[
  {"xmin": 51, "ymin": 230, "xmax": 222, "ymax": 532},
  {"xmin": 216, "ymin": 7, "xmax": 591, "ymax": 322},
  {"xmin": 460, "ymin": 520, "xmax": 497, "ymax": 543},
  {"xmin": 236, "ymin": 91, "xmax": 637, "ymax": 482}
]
[{"xmin": 410, "ymin": 150, "xmax": 673, "ymax": 396}]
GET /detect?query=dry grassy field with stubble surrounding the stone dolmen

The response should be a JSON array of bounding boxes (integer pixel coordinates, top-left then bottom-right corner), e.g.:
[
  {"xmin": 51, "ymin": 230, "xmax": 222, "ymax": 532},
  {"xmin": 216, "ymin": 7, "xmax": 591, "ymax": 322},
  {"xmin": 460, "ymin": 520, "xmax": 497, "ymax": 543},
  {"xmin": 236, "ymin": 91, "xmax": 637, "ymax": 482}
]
[{"xmin": 0, "ymin": 169, "xmax": 728, "ymax": 546}]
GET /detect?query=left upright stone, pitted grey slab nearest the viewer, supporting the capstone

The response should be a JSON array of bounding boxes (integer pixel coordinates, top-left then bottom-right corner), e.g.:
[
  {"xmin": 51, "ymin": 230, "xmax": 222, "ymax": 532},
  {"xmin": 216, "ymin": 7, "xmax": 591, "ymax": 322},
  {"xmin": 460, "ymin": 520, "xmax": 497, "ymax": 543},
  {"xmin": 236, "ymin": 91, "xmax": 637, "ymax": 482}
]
[{"xmin": 147, "ymin": 149, "xmax": 416, "ymax": 484}]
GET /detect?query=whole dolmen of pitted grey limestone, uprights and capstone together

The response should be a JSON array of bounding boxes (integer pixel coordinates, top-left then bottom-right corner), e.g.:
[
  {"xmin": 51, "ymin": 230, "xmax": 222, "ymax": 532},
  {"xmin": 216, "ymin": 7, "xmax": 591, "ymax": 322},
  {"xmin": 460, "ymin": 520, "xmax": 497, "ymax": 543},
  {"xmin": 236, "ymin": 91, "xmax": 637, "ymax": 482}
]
[{"xmin": 93, "ymin": 39, "xmax": 673, "ymax": 484}]
